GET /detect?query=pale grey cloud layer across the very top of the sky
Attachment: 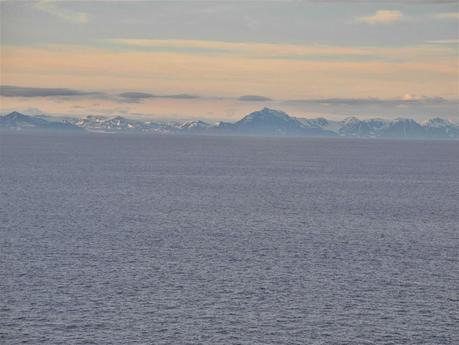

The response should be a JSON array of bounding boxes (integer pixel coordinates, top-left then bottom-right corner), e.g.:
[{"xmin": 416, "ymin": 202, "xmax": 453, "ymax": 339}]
[{"xmin": 1, "ymin": 0, "xmax": 457, "ymax": 46}]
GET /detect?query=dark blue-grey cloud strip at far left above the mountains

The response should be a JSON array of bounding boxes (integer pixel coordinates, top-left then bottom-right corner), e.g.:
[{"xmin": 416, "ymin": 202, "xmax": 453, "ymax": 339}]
[{"xmin": 0, "ymin": 85, "xmax": 104, "ymax": 97}]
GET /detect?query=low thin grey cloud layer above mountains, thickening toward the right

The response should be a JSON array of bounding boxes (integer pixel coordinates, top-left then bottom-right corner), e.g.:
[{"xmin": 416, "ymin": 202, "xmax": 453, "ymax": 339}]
[{"xmin": 0, "ymin": 85, "xmax": 459, "ymax": 117}]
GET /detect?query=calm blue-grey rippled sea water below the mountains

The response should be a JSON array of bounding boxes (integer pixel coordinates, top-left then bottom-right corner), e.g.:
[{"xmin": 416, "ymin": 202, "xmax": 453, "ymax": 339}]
[{"xmin": 0, "ymin": 133, "xmax": 459, "ymax": 345}]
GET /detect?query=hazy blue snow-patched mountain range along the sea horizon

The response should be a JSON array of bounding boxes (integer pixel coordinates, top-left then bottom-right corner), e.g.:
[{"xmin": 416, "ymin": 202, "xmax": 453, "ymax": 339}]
[{"xmin": 0, "ymin": 108, "xmax": 459, "ymax": 139}]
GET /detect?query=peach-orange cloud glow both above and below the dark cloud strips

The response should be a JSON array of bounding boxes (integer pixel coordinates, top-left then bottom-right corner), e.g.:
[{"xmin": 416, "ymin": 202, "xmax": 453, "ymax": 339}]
[{"xmin": 0, "ymin": 40, "xmax": 458, "ymax": 118}]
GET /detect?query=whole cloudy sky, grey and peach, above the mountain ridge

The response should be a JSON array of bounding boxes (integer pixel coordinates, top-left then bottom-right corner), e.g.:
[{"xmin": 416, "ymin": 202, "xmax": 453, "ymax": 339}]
[{"xmin": 0, "ymin": 0, "xmax": 459, "ymax": 122}]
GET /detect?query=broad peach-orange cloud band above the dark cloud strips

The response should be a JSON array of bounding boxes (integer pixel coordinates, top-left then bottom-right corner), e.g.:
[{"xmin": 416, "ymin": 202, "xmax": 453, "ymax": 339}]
[{"xmin": 2, "ymin": 42, "xmax": 457, "ymax": 102}]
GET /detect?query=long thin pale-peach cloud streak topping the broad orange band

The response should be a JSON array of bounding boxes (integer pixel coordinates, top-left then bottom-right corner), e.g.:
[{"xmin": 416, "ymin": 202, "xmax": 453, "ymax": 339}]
[{"xmin": 101, "ymin": 39, "xmax": 456, "ymax": 63}]
